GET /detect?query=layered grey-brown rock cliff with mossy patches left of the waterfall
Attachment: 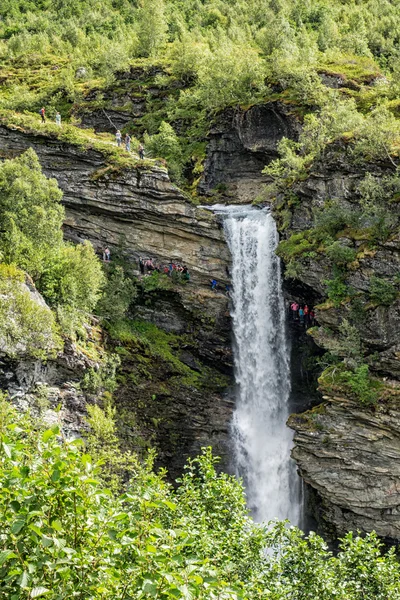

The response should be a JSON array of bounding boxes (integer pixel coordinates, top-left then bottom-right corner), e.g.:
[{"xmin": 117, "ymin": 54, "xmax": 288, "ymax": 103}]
[{"xmin": 0, "ymin": 127, "xmax": 232, "ymax": 476}]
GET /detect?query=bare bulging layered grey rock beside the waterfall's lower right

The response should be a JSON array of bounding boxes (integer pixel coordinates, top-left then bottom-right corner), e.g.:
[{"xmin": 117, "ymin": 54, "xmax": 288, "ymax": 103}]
[{"xmin": 289, "ymin": 383, "xmax": 400, "ymax": 541}]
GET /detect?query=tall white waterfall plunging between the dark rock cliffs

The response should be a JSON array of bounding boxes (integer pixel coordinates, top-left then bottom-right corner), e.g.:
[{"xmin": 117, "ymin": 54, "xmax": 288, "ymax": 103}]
[{"xmin": 213, "ymin": 206, "xmax": 302, "ymax": 525}]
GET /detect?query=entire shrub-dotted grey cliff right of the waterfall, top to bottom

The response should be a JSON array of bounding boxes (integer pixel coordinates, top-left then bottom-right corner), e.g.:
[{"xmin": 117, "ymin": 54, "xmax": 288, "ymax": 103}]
[{"xmin": 278, "ymin": 143, "xmax": 400, "ymax": 540}]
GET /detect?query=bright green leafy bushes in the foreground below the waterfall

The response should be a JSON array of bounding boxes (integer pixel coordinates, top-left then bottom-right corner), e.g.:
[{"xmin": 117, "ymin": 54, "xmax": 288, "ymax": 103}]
[{"xmin": 0, "ymin": 397, "xmax": 400, "ymax": 600}]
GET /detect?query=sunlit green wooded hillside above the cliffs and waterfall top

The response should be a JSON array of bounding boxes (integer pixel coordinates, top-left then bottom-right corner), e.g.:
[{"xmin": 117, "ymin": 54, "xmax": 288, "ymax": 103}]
[{"xmin": 0, "ymin": 0, "xmax": 400, "ymax": 189}]
